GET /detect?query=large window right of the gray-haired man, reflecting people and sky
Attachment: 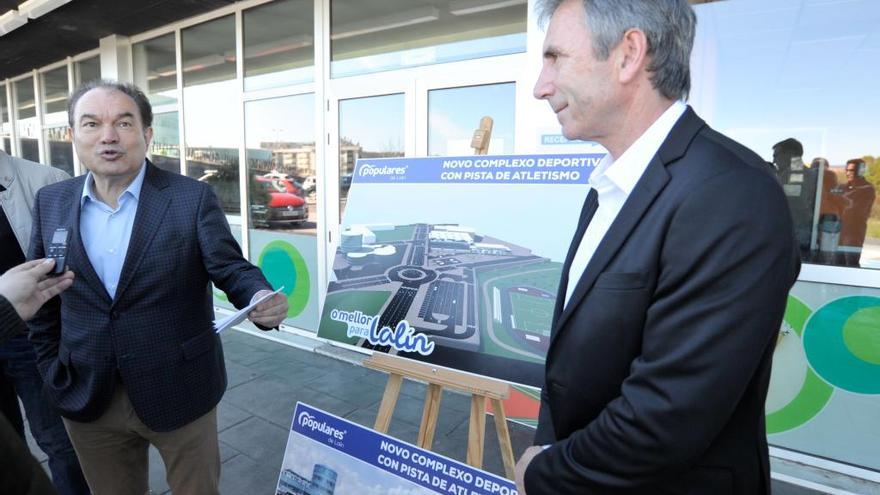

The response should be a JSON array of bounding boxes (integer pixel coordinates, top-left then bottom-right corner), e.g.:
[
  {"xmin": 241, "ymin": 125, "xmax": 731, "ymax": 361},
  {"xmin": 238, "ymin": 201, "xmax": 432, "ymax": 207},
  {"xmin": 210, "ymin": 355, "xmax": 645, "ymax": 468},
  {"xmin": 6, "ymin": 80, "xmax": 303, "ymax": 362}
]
[{"xmin": 692, "ymin": 0, "xmax": 880, "ymax": 268}]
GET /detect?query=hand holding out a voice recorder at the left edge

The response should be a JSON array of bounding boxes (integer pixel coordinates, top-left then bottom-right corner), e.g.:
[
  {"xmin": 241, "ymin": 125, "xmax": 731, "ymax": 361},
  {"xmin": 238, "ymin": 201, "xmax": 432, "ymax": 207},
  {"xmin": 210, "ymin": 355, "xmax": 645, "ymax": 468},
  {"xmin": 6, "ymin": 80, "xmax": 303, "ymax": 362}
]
[{"xmin": 0, "ymin": 259, "xmax": 73, "ymax": 320}]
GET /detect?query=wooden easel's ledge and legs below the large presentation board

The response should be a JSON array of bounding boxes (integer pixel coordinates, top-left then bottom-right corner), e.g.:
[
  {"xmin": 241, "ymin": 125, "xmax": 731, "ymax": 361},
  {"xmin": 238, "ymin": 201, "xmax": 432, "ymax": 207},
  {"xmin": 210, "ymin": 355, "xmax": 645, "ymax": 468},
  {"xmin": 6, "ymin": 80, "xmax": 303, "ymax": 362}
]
[{"xmin": 364, "ymin": 352, "xmax": 514, "ymax": 480}]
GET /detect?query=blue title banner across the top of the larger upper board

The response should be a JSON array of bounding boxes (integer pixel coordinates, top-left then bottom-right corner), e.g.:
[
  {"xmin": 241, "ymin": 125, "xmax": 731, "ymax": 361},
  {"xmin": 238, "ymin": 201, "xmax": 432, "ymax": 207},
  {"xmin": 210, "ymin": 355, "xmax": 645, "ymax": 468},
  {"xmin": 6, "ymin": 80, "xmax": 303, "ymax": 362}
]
[{"xmin": 352, "ymin": 154, "xmax": 604, "ymax": 184}]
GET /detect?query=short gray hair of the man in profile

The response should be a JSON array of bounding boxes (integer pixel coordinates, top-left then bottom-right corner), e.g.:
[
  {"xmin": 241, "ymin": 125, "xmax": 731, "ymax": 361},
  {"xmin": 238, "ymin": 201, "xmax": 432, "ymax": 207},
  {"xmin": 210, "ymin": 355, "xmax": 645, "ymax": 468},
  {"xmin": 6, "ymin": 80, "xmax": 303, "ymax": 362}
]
[{"xmin": 535, "ymin": 0, "xmax": 697, "ymax": 100}]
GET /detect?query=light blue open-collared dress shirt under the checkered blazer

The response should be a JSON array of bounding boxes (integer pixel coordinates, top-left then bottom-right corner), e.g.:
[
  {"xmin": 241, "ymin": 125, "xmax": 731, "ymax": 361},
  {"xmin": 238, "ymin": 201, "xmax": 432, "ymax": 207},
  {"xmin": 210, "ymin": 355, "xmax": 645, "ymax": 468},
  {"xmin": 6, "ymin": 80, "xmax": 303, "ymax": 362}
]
[{"xmin": 79, "ymin": 163, "xmax": 147, "ymax": 299}]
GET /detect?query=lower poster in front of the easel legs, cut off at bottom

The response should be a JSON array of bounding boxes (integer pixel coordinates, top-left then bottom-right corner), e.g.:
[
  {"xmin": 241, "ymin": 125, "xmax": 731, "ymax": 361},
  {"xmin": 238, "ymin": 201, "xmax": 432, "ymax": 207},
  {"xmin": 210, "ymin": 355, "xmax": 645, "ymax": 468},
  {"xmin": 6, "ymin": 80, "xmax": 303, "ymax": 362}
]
[{"xmin": 276, "ymin": 403, "xmax": 517, "ymax": 495}]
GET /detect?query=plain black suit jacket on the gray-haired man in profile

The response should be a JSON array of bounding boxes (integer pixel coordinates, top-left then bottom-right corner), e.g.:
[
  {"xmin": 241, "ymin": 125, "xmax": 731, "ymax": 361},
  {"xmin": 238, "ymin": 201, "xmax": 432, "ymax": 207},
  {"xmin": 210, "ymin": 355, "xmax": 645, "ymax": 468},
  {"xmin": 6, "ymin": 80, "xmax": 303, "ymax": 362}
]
[{"xmin": 525, "ymin": 108, "xmax": 800, "ymax": 495}]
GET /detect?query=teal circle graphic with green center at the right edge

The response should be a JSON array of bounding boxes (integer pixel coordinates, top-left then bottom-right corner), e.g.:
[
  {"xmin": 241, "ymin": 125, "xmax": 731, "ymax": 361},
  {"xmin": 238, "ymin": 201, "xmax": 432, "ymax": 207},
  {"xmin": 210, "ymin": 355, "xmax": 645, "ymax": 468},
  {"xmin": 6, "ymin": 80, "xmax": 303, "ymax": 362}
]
[{"xmin": 803, "ymin": 296, "xmax": 880, "ymax": 394}]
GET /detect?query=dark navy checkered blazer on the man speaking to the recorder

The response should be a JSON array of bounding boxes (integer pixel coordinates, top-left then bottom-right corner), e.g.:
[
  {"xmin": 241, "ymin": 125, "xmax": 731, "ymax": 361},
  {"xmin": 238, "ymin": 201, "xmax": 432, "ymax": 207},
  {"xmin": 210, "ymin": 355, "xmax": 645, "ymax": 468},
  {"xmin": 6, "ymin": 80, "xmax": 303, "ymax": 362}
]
[{"xmin": 29, "ymin": 162, "xmax": 270, "ymax": 431}]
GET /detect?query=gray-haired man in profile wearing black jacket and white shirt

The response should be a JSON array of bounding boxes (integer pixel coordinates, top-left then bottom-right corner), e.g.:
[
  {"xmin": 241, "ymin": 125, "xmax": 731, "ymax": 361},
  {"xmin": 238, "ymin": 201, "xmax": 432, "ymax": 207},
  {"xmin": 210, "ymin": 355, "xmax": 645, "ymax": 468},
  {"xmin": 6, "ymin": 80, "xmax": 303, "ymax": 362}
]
[{"xmin": 516, "ymin": 0, "xmax": 799, "ymax": 495}]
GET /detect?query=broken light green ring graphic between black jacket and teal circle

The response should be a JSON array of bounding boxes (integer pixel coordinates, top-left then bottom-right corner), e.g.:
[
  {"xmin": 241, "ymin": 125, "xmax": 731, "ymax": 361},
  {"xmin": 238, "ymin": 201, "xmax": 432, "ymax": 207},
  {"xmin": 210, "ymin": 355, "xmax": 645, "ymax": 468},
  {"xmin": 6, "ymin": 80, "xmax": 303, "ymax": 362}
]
[{"xmin": 766, "ymin": 295, "xmax": 834, "ymax": 434}]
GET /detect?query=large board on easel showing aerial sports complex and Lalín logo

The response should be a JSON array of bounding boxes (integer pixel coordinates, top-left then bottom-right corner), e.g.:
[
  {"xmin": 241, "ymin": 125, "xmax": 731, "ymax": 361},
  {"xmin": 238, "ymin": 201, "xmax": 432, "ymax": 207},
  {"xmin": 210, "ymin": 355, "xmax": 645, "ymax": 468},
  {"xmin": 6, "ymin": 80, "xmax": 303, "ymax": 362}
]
[{"xmin": 318, "ymin": 154, "xmax": 603, "ymax": 386}]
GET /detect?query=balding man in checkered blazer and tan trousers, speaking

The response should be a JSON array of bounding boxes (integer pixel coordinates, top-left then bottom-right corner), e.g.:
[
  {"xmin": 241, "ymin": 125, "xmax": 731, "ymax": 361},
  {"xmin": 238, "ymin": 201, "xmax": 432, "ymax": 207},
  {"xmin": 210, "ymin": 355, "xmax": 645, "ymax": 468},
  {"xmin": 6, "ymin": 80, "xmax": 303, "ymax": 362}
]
[{"xmin": 30, "ymin": 81, "xmax": 287, "ymax": 495}]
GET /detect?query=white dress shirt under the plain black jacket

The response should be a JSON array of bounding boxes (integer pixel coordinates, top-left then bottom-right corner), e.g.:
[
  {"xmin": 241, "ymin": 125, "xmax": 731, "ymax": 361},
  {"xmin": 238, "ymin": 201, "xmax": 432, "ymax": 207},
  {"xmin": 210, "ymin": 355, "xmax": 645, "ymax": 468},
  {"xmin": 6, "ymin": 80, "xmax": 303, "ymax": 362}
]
[{"xmin": 565, "ymin": 101, "xmax": 687, "ymax": 306}]
